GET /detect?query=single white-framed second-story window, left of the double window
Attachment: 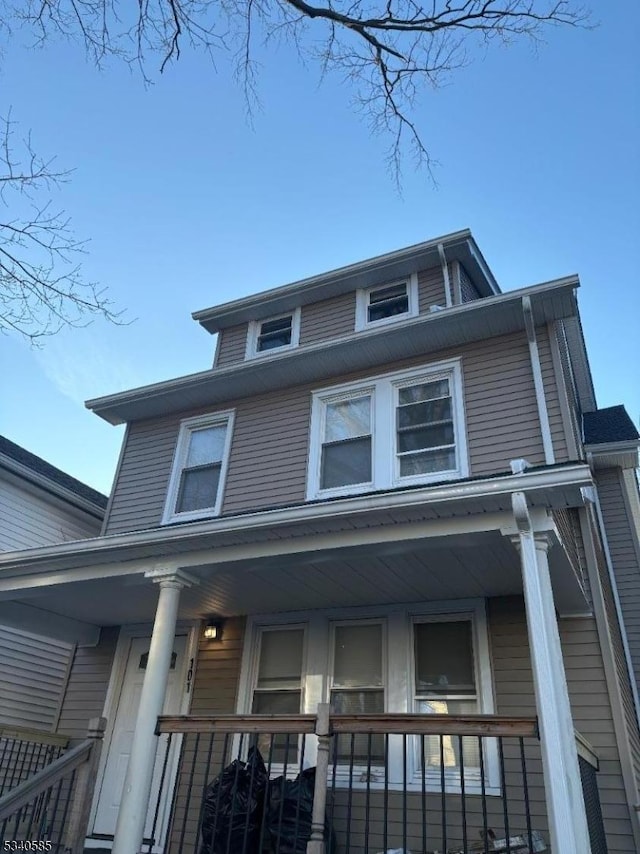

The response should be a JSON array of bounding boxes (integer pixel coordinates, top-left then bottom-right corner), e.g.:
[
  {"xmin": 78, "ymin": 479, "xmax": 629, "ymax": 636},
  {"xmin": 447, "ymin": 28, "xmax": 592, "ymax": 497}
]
[{"xmin": 162, "ymin": 412, "xmax": 233, "ymax": 523}]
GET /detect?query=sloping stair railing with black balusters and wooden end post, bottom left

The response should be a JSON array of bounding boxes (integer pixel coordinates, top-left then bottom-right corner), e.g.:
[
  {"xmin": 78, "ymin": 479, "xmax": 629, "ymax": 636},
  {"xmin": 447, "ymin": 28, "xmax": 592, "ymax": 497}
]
[{"xmin": 0, "ymin": 719, "xmax": 105, "ymax": 854}]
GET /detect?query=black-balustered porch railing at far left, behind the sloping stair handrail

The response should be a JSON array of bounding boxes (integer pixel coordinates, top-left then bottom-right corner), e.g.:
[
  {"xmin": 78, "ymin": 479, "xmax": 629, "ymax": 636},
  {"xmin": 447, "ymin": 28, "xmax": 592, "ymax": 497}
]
[{"xmin": 0, "ymin": 726, "xmax": 69, "ymax": 797}]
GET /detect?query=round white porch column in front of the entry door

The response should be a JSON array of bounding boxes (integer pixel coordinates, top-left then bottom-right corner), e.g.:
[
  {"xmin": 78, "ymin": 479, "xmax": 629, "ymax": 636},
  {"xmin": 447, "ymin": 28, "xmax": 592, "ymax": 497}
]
[{"xmin": 112, "ymin": 569, "xmax": 197, "ymax": 854}]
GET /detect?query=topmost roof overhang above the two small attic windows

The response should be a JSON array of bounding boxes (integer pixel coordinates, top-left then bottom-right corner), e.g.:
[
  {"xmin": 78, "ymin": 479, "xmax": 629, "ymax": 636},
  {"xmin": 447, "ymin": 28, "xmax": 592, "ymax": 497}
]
[{"xmin": 192, "ymin": 229, "xmax": 500, "ymax": 334}]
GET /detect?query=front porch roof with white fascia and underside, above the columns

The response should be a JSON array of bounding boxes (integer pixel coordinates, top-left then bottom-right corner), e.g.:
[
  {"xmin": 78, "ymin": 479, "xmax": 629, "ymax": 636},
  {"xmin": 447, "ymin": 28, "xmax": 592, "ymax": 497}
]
[{"xmin": 0, "ymin": 465, "xmax": 592, "ymax": 642}]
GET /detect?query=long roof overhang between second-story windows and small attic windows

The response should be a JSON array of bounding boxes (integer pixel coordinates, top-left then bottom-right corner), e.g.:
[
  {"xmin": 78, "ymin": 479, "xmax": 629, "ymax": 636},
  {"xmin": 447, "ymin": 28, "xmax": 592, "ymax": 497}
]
[{"xmin": 86, "ymin": 276, "xmax": 579, "ymax": 424}]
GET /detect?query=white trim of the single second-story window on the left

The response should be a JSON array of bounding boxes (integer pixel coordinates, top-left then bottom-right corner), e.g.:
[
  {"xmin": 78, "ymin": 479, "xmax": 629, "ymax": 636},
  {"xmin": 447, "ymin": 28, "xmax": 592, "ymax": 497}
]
[{"xmin": 162, "ymin": 409, "xmax": 235, "ymax": 525}]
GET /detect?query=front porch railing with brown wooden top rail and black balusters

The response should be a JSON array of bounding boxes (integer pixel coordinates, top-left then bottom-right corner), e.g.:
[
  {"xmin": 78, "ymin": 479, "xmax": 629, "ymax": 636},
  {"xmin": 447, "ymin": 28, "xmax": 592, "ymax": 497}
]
[{"xmin": 154, "ymin": 715, "xmax": 548, "ymax": 854}]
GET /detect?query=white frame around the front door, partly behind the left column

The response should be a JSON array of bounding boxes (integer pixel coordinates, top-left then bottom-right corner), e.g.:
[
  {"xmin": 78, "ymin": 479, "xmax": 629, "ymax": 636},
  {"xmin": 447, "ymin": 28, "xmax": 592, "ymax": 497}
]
[{"xmin": 85, "ymin": 620, "xmax": 201, "ymax": 848}]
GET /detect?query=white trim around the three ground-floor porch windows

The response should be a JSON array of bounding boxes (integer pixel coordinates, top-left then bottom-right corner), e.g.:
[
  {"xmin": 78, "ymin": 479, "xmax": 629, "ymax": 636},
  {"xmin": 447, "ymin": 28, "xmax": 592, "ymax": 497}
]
[{"xmin": 236, "ymin": 599, "xmax": 500, "ymax": 795}]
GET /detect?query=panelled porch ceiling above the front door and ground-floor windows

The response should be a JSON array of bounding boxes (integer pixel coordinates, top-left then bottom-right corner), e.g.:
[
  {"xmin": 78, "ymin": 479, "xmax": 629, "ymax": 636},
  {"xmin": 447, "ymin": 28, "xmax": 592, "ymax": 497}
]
[{"xmin": 0, "ymin": 531, "xmax": 584, "ymax": 627}]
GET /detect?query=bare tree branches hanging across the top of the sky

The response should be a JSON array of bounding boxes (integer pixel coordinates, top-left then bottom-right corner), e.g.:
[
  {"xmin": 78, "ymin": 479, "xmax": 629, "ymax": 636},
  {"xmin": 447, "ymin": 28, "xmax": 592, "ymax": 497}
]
[{"xmin": 0, "ymin": 0, "xmax": 588, "ymax": 174}]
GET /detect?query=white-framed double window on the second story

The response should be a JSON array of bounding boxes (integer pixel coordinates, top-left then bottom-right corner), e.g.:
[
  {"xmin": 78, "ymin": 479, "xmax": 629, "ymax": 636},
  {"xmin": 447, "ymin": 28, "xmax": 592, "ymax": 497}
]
[{"xmin": 307, "ymin": 361, "xmax": 468, "ymax": 500}]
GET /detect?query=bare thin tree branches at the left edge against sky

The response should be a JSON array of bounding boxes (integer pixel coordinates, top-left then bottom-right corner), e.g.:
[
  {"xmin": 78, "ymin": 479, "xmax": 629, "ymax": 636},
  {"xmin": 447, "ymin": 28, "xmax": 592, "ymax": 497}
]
[{"xmin": 0, "ymin": 114, "xmax": 122, "ymax": 342}]
